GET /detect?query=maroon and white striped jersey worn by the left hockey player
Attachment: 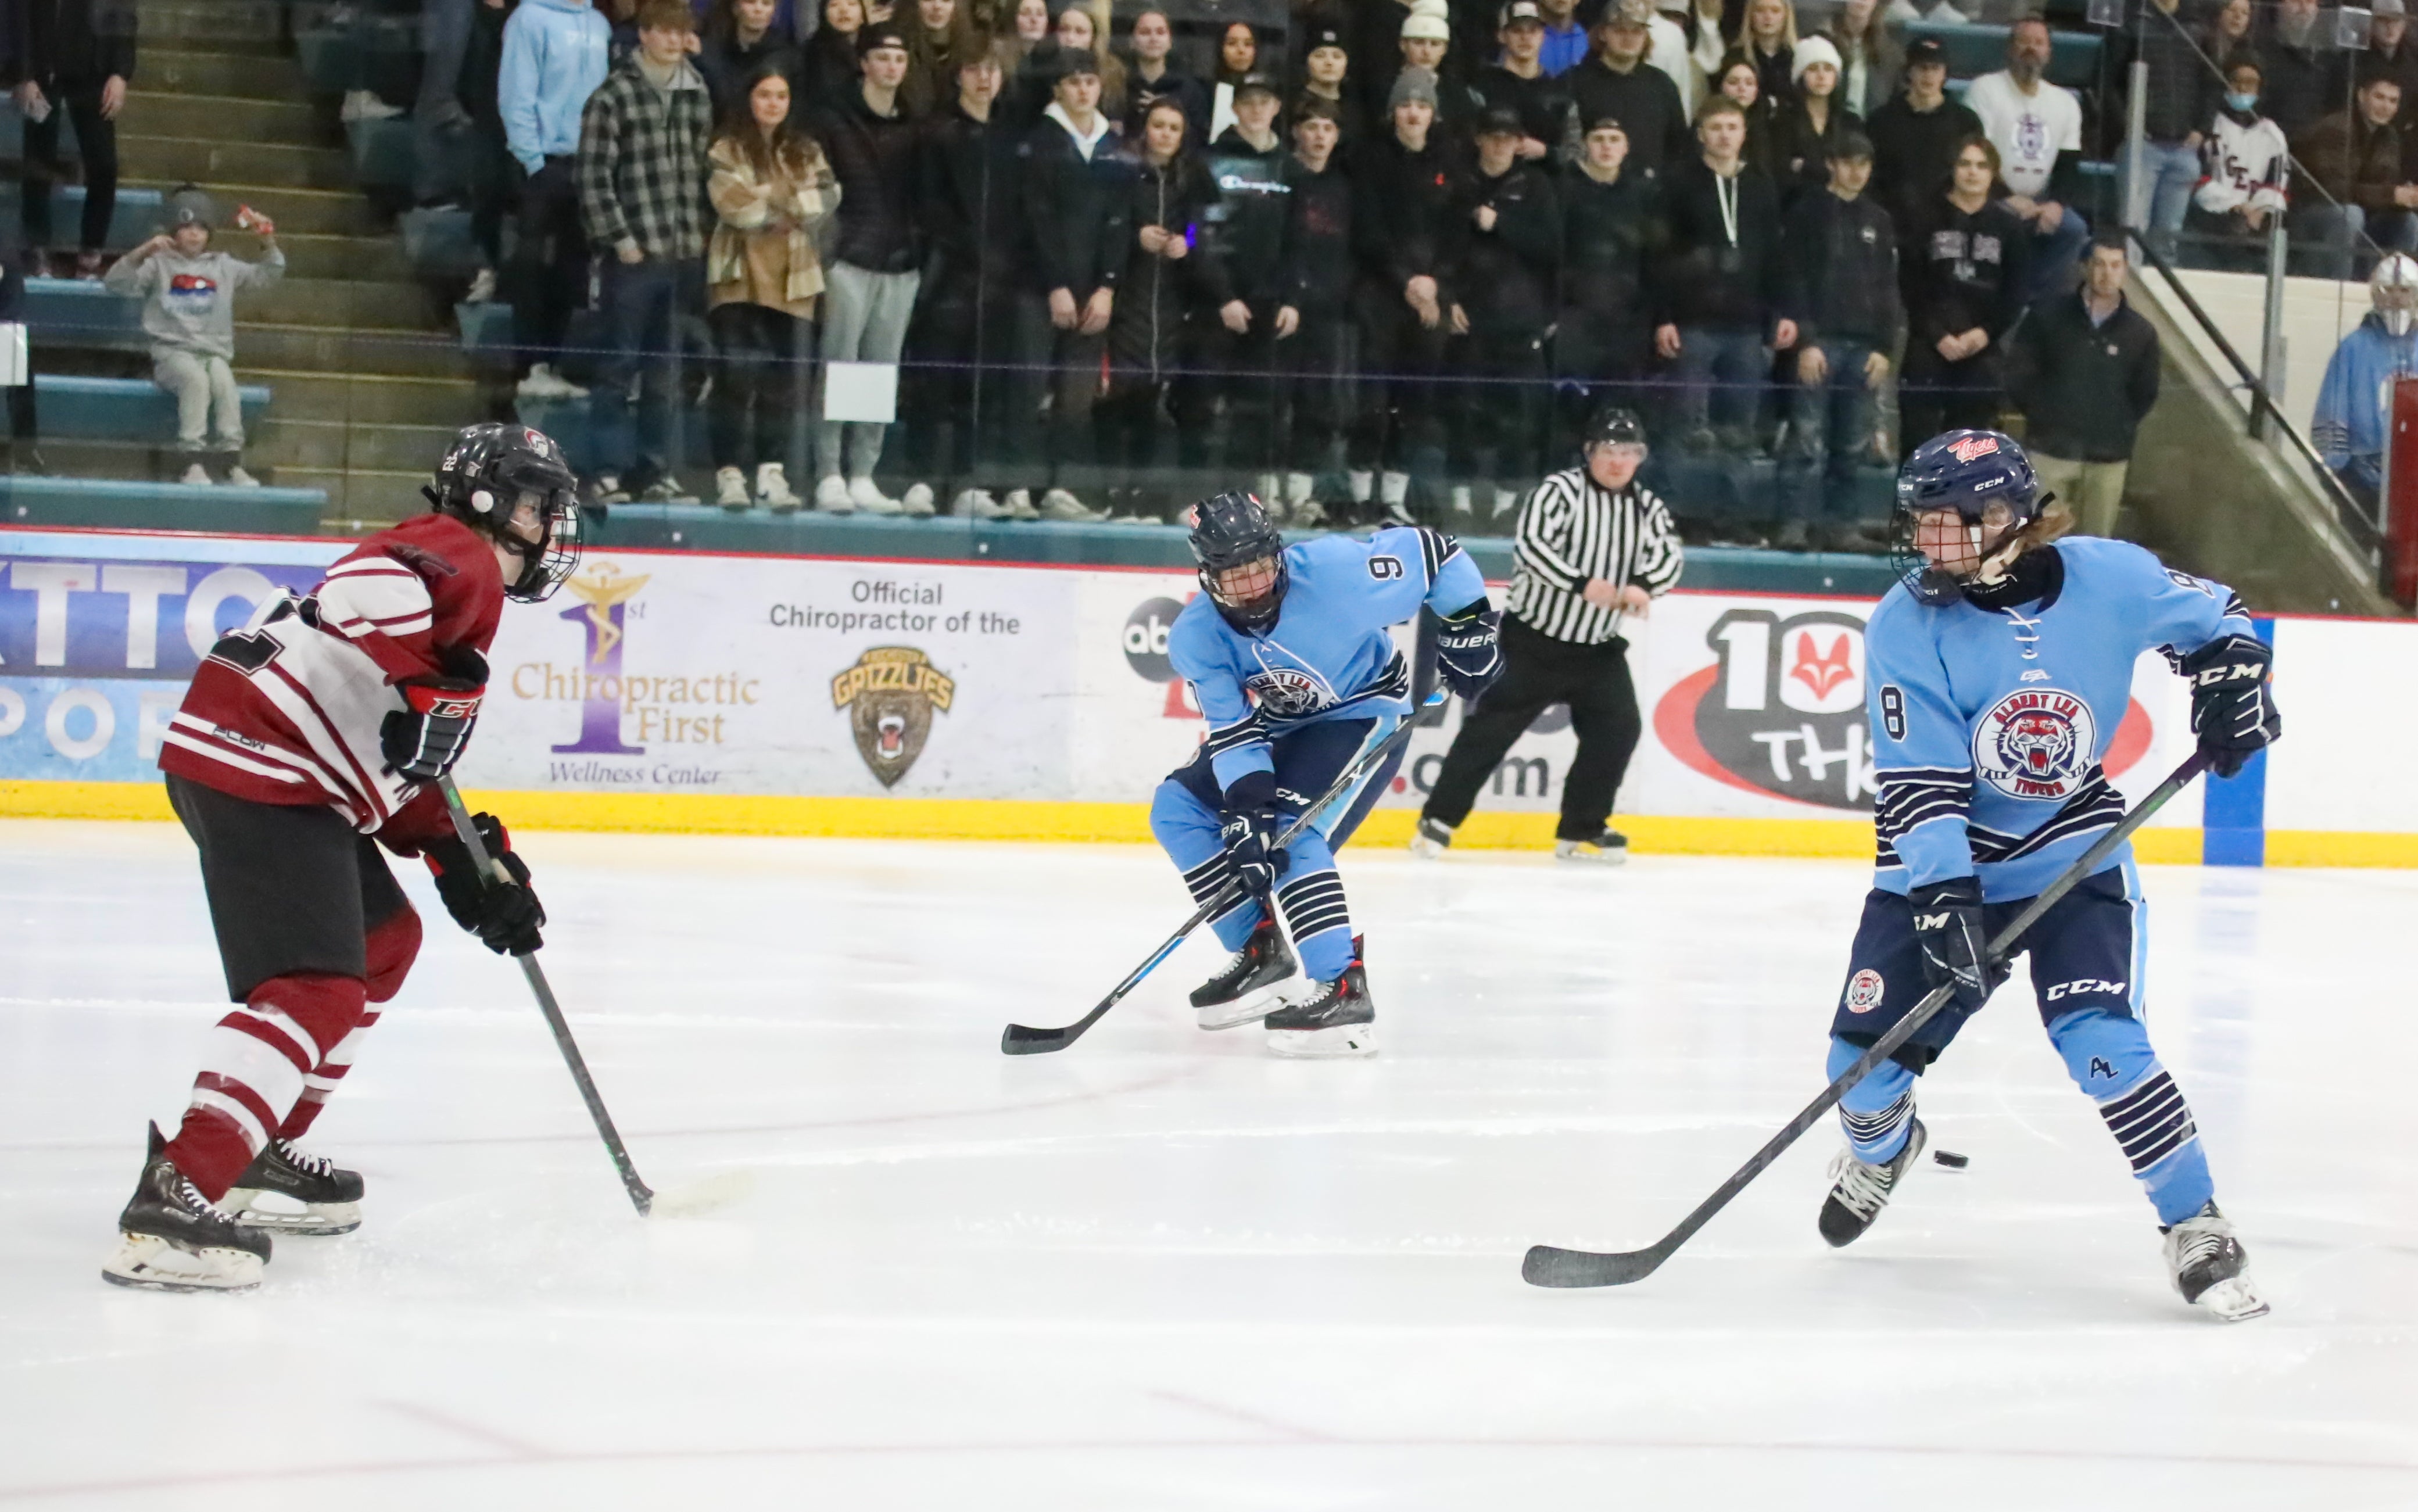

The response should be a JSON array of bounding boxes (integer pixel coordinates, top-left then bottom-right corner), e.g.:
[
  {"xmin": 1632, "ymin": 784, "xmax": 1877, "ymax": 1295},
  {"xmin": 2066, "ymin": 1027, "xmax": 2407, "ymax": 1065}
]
[{"xmin": 160, "ymin": 515, "xmax": 503, "ymax": 840}]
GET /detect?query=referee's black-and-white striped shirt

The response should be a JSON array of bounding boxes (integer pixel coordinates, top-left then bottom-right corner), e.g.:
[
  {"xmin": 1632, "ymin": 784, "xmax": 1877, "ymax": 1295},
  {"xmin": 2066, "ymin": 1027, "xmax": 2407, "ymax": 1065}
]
[{"xmin": 1511, "ymin": 467, "xmax": 1681, "ymax": 646}]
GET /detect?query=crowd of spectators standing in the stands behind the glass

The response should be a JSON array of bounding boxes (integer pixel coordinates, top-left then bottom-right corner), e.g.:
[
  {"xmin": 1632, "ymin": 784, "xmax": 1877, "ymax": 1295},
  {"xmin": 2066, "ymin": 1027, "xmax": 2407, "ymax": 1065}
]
[{"xmin": 33, "ymin": 0, "xmax": 2418, "ymax": 547}]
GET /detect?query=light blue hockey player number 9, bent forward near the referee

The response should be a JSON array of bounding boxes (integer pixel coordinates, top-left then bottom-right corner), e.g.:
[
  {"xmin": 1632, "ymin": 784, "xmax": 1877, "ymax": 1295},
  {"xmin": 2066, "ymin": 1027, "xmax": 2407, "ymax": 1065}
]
[{"xmin": 1151, "ymin": 493, "xmax": 1499, "ymax": 1055}]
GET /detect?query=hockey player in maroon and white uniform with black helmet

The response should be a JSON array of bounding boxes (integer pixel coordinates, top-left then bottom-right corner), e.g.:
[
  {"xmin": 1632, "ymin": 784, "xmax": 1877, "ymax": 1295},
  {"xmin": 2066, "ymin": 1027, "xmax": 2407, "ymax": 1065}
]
[{"xmin": 102, "ymin": 426, "xmax": 581, "ymax": 1292}]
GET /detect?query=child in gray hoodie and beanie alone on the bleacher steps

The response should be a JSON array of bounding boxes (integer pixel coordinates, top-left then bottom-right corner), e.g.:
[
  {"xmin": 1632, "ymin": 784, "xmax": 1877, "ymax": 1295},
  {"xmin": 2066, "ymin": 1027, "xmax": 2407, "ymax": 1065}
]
[{"xmin": 102, "ymin": 184, "xmax": 285, "ymax": 489}]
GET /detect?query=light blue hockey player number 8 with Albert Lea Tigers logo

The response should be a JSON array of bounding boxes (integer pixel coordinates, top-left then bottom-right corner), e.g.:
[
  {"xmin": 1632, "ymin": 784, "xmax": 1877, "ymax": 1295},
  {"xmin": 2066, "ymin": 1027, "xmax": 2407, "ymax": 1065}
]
[{"xmin": 1821, "ymin": 431, "xmax": 2280, "ymax": 1321}]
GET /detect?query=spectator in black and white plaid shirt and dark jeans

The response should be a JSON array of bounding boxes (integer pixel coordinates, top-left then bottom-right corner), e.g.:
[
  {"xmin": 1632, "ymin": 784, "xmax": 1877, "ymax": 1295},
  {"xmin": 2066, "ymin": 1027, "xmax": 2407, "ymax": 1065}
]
[{"xmin": 578, "ymin": 0, "xmax": 713, "ymax": 503}]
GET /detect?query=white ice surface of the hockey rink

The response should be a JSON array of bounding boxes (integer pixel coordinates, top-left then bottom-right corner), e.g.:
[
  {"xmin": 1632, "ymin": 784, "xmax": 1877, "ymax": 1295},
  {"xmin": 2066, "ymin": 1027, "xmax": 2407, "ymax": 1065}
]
[{"xmin": 0, "ymin": 820, "xmax": 2418, "ymax": 1512}]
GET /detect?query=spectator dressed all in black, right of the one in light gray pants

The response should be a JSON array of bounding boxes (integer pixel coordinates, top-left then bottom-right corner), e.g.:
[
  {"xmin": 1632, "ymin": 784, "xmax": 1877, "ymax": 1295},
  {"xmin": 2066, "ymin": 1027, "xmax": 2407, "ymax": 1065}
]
[{"xmin": 907, "ymin": 46, "xmax": 1025, "ymax": 520}]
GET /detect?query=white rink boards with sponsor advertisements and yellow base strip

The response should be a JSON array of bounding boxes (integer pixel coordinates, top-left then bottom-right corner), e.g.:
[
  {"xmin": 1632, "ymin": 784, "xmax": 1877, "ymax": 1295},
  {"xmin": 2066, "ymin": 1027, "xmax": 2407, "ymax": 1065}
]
[{"xmin": 0, "ymin": 530, "xmax": 2418, "ymax": 866}]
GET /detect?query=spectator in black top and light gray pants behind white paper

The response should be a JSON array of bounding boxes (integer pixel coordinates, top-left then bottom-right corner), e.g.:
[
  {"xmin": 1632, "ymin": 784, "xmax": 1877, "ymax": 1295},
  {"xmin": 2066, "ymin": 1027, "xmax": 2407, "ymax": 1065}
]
[{"xmin": 815, "ymin": 27, "xmax": 933, "ymax": 515}]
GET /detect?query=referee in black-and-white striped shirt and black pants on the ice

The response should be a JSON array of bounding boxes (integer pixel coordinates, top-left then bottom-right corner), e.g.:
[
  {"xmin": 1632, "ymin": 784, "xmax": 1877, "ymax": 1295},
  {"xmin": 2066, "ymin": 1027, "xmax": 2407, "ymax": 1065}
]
[{"xmin": 1410, "ymin": 409, "xmax": 1681, "ymax": 861}]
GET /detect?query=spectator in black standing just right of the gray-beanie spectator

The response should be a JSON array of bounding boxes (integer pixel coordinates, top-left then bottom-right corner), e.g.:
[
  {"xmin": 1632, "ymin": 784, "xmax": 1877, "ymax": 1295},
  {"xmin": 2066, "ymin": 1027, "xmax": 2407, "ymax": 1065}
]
[{"xmin": 1451, "ymin": 106, "xmax": 1562, "ymax": 530}]
